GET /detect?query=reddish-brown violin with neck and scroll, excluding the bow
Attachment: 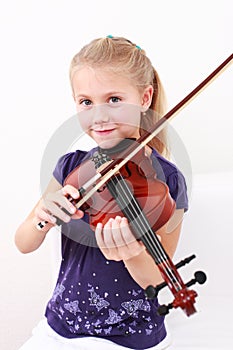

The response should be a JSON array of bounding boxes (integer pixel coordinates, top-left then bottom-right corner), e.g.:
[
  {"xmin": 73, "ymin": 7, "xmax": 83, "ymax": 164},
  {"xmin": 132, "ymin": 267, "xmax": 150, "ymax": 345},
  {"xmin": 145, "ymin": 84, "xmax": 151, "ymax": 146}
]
[{"xmin": 64, "ymin": 139, "xmax": 202, "ymax": 316}]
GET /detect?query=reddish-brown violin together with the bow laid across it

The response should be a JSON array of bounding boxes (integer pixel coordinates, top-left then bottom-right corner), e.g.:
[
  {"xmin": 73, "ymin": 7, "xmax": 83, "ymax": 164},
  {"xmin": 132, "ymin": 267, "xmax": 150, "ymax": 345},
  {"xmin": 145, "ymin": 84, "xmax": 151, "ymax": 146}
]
[{"xmin": 37, "ymin": 55, "xmax": 233, "ymax": 316}]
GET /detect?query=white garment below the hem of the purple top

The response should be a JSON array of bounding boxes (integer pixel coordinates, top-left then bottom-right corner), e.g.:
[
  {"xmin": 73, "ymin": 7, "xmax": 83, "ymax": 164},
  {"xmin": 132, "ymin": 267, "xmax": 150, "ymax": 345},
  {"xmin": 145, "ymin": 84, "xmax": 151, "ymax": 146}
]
[{"xmin": 19, "ymin": 319, "xmax": 170, "ymax": 350}]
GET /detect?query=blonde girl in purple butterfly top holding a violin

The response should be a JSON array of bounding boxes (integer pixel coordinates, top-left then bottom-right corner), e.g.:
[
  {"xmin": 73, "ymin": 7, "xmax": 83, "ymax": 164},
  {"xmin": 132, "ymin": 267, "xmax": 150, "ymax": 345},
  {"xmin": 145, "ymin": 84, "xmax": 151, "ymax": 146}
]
[{"xmin": 15, "ymin": 36, "xmax": 187, "ymax": 350}]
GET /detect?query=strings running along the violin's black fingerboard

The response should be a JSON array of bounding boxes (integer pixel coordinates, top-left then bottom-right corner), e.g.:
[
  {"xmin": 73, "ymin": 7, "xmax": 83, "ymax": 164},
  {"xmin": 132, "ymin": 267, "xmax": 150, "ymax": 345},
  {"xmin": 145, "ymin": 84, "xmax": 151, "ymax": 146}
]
[{"xmin": 108, "ymin": 173, "xmax": 182, "ymax": 290}]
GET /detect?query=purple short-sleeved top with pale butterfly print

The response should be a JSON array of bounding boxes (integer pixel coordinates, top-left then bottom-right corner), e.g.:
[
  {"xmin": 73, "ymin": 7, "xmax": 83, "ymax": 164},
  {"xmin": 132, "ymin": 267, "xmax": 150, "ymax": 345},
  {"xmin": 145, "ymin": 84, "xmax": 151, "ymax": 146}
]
[{"xmin": 46, "ymin": 146, "xmax": 188, "ymax": 349}]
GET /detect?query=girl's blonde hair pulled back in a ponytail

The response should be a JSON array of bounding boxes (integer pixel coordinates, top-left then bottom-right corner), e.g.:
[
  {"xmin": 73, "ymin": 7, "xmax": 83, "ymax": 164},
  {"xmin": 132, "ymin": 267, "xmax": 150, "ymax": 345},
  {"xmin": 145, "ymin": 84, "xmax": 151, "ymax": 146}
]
[{"xmin": 70, "ymin": 36, "xmax": 168, "ymax": 155}]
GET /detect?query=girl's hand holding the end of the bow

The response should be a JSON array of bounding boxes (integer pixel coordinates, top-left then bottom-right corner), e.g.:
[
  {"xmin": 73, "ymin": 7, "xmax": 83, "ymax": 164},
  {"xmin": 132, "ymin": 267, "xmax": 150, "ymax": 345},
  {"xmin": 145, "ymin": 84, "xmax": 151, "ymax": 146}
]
[{"xmin": 35, "ymin": 185, "xmax": 83, "ymax": 228}]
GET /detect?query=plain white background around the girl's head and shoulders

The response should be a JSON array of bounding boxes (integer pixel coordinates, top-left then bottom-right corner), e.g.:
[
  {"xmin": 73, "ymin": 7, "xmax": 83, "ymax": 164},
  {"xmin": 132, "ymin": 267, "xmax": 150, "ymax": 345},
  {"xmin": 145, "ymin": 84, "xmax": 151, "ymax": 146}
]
[{"xmin": 0, "ymin": 0, "xmax": 233, "ymax": 350}]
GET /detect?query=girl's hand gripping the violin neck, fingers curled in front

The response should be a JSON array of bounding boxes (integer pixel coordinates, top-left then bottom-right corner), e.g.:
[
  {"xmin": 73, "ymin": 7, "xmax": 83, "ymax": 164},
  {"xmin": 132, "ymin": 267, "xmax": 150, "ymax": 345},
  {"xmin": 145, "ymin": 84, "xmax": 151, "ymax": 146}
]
[{"xmin": 95, "ymin": 216, "xmax": 145, "ymax": 261}]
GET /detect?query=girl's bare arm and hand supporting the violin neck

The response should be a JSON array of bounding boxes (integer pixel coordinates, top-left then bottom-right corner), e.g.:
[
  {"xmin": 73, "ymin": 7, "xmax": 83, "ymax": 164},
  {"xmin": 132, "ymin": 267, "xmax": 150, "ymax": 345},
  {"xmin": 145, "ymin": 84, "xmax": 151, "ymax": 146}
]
[{"xmin": 96, "ymin": 209, "xmax": 184, "ymax": 289}]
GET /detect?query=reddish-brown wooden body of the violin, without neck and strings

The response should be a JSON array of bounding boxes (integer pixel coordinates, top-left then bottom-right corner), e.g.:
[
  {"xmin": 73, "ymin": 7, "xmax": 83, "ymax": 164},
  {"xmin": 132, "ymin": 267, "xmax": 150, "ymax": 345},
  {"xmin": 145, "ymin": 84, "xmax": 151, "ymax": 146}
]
[{"xmin": 65, "ymin": 146, "xmax": 175, "ymax": 231}]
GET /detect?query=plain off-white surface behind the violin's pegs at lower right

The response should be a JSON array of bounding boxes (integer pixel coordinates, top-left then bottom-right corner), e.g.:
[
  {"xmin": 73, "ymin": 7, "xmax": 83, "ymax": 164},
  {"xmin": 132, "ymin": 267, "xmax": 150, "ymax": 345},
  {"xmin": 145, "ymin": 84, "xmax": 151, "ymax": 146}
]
[{"xmin": 166, "ymin": 173, "xmax": 233, "ymax": 350}]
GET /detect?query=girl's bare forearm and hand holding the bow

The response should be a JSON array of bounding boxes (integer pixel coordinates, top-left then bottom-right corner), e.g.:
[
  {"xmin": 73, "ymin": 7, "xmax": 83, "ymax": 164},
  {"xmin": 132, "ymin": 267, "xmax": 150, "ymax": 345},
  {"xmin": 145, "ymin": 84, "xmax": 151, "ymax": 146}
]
[{"xmin": 15, "ymin": 178, "xmax": 83, "ymax": 253}]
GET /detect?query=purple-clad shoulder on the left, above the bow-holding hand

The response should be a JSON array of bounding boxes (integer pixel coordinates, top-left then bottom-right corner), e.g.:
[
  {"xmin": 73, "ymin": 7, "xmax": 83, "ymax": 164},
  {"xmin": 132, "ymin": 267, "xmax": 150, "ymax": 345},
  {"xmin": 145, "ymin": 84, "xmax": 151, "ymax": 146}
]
[{"xmin": 53, "ymin": 149, "xmax": 95, "ymax": 185}]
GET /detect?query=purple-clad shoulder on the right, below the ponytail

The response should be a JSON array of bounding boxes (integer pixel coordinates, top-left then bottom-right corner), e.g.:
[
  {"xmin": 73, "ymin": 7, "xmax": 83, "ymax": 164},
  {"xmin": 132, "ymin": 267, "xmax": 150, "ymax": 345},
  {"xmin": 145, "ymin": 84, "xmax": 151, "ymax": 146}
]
[{"xmin": 151, "ymin": 149, "xmax": 188, "ymax": 211}]
